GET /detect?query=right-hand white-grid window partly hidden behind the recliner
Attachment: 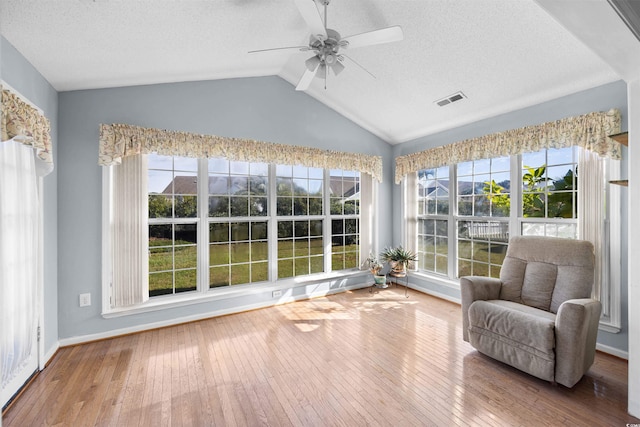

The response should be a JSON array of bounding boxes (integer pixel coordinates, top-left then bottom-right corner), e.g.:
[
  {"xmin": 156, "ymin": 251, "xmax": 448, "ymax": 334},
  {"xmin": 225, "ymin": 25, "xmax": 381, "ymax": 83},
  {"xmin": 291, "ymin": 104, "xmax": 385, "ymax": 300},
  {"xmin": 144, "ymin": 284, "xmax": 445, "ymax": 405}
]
[{"xmin": 417, "ymin": 147, "xmax": 580, "ymax": 279}]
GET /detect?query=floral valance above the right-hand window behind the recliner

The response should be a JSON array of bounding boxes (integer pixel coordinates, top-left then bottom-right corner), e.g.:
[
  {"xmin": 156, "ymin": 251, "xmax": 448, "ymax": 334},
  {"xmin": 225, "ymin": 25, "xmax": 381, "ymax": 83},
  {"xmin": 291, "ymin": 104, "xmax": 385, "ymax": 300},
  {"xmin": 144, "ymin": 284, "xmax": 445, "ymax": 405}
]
[{"xmin": 395, "ymin": 110, "xmax": 621, "ymax": 184}]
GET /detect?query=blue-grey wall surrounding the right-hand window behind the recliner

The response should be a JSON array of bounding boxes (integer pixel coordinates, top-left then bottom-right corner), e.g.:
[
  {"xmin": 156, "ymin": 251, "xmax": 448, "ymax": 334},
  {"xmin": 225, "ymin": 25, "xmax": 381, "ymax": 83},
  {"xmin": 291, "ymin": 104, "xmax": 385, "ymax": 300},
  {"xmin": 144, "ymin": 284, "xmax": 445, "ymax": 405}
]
[{"xmin": 393, "ymin": 81, "xmax": 628, "ymax": 352}]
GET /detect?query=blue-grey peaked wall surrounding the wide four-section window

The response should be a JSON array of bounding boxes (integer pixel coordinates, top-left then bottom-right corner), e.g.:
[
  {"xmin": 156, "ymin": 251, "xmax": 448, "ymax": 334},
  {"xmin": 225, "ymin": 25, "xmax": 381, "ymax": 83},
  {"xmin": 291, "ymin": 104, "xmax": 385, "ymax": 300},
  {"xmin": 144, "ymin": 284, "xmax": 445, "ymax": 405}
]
[{"xmin": 58, "ymin": 77, "xmax": 392, "ymax": 339}]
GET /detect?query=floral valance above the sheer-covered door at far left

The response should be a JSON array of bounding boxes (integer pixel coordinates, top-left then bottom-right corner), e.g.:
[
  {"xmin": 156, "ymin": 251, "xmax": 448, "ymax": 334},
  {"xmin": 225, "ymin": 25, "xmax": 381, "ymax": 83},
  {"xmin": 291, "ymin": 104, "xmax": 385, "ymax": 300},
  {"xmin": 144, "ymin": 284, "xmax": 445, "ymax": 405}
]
[{"xmin": 0, "ymin": 88, "xmax": 53, "ymax": 175}]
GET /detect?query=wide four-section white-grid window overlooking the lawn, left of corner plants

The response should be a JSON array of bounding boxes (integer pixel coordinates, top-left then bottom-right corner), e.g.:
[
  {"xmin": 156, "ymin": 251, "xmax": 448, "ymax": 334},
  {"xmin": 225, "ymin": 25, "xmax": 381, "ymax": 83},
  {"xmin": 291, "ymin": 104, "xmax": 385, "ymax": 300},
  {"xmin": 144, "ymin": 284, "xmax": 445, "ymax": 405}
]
[{"xmin": 147, "ymin": 154, "xmax": 360, "ymax": 297}]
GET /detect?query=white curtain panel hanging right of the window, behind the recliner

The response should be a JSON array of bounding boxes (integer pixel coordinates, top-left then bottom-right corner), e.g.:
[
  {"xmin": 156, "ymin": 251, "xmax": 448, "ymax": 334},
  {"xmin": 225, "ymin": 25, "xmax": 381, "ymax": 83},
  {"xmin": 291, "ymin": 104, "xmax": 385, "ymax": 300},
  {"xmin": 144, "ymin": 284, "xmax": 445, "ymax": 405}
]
[{"xmin": 577, "ymin": 149, "xmax": 609, "ymax": 307}]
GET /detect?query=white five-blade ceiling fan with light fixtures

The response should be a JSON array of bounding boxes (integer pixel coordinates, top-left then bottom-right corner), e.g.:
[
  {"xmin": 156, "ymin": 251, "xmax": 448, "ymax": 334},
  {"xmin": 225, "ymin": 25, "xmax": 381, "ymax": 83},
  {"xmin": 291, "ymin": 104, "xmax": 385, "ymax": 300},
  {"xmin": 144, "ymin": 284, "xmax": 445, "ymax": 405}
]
[{"xmin": 249, "ymin": 0, "xmax": 404, "ymax": 90}]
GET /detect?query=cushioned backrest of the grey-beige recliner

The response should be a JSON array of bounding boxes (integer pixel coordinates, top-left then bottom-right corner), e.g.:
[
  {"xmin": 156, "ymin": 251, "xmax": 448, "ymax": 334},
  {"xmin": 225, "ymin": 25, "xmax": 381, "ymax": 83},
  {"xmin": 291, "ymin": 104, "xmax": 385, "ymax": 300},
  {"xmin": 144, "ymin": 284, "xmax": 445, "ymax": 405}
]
[{"xmin": 500, "ymin": 236, "xmax": 594, "ymax": 313}]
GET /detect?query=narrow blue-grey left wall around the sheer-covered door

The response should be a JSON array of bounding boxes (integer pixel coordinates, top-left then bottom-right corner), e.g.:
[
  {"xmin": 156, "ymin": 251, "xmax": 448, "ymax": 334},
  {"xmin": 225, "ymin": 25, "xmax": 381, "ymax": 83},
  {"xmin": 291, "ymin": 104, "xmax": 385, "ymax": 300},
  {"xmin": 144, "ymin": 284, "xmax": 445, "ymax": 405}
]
[{"xmin": 0, "ymin": 37, "xmax": 59, "ymax": 353}]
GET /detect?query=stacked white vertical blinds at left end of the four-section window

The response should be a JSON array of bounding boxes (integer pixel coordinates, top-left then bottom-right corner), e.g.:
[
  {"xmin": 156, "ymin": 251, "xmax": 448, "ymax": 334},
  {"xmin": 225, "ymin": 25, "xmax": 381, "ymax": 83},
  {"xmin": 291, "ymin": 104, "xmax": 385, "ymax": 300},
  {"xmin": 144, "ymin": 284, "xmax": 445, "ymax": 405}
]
[{"xmin": 109, "ymin": 154, "xmax": 149, "ymax": 308}]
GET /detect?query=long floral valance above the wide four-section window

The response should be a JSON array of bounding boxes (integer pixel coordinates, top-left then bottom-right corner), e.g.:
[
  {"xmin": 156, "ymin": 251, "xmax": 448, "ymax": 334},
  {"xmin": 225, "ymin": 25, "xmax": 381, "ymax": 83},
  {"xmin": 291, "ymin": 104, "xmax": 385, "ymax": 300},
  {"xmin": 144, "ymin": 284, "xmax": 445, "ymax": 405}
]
[{"xmin": 99, "ymin": 124, "xmax": 382, "ymax": 182}]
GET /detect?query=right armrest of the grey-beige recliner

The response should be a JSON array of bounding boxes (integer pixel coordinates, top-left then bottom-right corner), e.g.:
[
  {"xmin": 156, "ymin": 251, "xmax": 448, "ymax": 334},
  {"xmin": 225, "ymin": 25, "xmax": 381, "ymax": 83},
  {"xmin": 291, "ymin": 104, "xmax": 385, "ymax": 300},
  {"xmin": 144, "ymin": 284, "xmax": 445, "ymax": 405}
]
[{"xmin": 555, "ymin": 298, "xmax": 602, "ymax": 387}]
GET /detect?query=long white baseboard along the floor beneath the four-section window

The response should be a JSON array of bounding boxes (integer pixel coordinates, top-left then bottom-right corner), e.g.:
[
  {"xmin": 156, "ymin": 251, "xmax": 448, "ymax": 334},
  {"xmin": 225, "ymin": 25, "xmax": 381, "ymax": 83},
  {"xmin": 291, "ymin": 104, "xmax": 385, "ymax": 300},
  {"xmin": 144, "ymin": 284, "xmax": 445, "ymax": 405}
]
[{"xmin": 59, "ymin": 283, "xmax": 368, "ymax": 347}]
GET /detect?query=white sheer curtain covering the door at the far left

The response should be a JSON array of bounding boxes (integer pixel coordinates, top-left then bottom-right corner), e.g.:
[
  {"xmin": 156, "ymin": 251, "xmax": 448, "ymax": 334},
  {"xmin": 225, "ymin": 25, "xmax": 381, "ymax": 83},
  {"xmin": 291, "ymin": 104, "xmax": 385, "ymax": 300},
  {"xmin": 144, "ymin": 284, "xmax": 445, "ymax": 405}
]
[{"xmin": 0, "ymin": 140, "xmax": 41, "ymax": 390}]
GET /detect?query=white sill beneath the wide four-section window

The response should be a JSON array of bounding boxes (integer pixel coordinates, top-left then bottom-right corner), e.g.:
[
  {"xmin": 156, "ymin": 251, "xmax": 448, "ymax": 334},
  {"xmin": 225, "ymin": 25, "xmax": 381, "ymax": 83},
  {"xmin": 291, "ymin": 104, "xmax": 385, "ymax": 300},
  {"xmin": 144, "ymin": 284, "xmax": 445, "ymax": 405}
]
[{"xmin": 102, "ymin": 270, "xmax": 371, "ymax": 319}]
